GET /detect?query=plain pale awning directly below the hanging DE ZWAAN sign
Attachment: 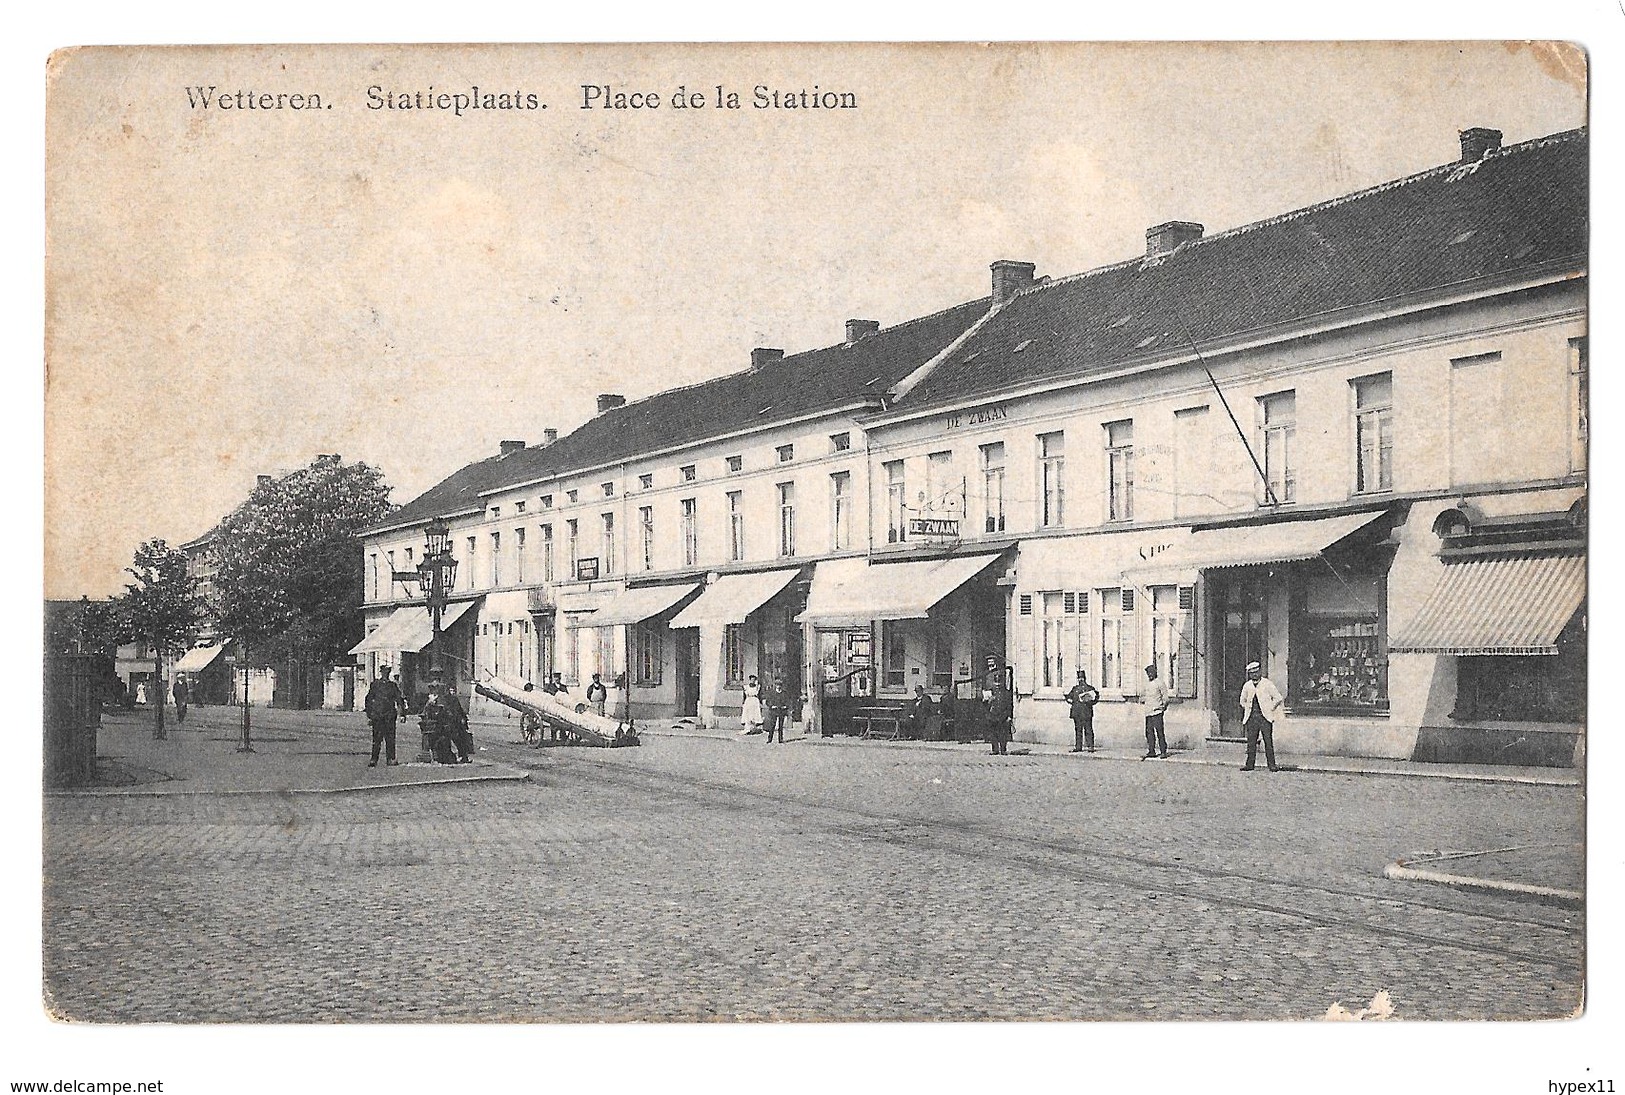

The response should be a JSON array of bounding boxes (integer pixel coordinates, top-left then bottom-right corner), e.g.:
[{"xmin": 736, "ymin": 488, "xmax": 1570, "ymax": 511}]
[{"xmin": 796, "ymin": 554, "xmax": 999, "ymax": 627}]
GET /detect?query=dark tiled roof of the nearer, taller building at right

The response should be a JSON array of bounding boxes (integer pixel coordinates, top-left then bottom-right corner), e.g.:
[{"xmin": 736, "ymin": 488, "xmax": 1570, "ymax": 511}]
[{"xmin": 897, "ymin": 130, "xmax": 1588, "ymax": 413}]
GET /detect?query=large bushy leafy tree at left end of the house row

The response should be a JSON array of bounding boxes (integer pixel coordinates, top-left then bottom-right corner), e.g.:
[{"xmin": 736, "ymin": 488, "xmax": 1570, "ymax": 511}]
[{"xmin": 211, "ymin": 457, "xmax": 393, "ymax": 698}]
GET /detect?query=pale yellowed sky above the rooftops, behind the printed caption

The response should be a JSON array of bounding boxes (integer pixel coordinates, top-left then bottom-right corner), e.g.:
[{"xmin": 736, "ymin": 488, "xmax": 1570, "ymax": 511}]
[{"xmin": 46, "ymin": 42, "xmax": 1586, "ymax": 596}]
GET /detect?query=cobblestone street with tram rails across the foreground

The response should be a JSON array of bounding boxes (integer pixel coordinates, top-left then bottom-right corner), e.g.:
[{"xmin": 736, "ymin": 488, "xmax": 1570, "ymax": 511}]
[{"xmin": 44, "ymin": 726, "xmax": 1583, "ymax": 1022}]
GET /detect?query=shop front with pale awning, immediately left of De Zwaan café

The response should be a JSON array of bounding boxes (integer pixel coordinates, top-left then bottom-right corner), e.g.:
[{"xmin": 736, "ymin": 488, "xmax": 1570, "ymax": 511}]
[{"xmin": 671, "ymin": 567, "xmax": 808, "ymax": 728}]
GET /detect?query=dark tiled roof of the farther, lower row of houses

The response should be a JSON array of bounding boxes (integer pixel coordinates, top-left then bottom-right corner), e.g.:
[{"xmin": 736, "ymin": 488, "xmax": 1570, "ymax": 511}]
[{"xmin": 375, "ymin": 297, "xmax": 990, "ymax": 528}]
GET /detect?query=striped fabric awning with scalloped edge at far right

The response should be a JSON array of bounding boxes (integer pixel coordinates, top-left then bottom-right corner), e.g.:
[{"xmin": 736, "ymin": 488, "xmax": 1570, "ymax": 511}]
[{"xmin": 1388, "ymin": 554, "xmax": 1586, "ymax": 655}]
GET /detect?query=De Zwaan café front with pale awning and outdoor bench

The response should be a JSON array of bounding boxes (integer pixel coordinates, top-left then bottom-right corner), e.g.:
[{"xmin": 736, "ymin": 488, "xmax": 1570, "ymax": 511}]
[{"xmin": 798, "ymin": 552, "xmax": 1009, "ymax": 736}]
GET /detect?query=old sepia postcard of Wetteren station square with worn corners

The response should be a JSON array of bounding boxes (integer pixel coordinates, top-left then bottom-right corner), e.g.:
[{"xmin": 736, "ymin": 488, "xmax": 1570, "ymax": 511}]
[{"xmin": 42, "ymin": 42, "xmax": 1589, "ymax": 1046}]
